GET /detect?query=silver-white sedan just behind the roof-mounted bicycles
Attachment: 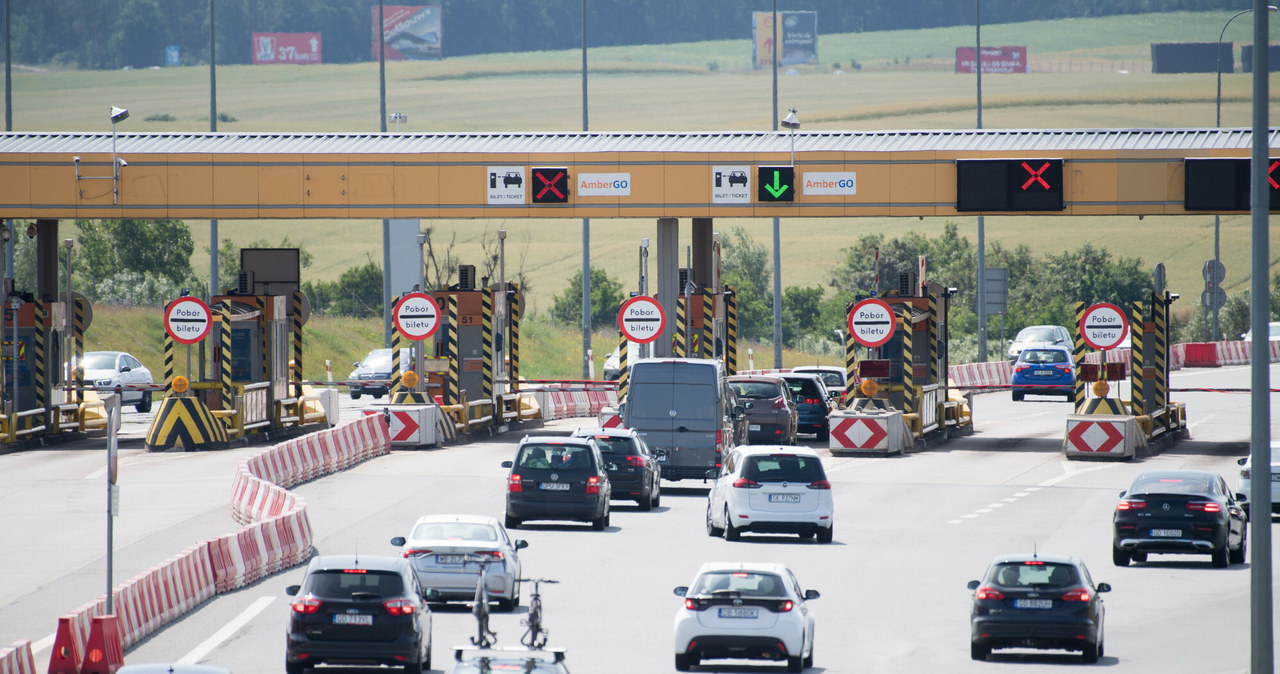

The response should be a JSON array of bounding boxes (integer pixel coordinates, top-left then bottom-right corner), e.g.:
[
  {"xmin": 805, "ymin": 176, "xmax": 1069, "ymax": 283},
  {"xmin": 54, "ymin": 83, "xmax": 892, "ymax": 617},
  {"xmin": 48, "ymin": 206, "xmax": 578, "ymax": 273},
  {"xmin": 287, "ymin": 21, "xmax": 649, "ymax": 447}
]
[{"xmin": 392, "ymin": 515, "xmax": 529, "ymax": 611}]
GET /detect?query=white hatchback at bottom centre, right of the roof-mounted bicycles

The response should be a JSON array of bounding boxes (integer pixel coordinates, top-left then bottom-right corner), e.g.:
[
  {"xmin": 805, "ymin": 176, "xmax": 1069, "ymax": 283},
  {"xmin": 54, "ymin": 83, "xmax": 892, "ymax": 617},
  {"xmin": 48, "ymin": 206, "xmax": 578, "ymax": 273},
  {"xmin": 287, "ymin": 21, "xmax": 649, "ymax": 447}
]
[{"xmin": 675, "ymin": 561, "xmax": 819, "ymax": 671}]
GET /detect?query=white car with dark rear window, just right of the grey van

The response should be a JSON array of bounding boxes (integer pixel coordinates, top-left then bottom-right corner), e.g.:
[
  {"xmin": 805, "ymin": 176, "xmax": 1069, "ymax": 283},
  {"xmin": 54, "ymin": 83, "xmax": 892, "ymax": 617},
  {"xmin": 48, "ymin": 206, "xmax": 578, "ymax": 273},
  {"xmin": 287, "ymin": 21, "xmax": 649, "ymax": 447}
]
[{"xmin": 707, "ymin": 445, "xmax": 836, "ymax": 544}]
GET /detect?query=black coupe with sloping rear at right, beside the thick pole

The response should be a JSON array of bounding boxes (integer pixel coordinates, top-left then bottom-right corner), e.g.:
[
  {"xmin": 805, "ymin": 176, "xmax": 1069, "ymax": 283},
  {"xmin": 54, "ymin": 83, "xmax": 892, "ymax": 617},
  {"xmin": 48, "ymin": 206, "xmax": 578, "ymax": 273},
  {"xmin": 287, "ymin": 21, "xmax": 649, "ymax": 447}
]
[{"xmin": 1111, "ymin": 471, "xmax": 1248, "ymax": 568}]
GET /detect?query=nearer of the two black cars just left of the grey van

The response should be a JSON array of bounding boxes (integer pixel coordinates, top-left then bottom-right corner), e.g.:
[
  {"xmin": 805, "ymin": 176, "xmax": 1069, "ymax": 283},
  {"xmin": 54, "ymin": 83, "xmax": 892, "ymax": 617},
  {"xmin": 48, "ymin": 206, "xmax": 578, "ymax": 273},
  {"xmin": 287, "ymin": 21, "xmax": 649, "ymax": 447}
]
[{"xmin": 502, "ymin": 437, "xmax": 613, "ymax": 531}]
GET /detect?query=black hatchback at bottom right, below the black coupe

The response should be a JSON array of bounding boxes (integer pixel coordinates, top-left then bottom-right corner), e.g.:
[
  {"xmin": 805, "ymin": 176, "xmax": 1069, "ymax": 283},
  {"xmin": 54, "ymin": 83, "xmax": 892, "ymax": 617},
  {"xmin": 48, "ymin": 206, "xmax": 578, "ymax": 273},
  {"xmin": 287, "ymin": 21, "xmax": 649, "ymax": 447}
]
[{"xmin": 969, "ymin": 555, "xmax": 1111, "ymax": 662}]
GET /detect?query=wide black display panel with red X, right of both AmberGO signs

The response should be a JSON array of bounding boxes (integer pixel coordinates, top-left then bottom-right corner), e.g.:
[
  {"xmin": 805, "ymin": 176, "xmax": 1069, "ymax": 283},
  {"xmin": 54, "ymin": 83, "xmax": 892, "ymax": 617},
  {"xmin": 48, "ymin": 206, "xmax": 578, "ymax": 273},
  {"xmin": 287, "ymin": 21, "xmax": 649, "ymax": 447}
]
[{"xmin": 956, "ymin": 159, "xmax": 1066, "ymax": 211}]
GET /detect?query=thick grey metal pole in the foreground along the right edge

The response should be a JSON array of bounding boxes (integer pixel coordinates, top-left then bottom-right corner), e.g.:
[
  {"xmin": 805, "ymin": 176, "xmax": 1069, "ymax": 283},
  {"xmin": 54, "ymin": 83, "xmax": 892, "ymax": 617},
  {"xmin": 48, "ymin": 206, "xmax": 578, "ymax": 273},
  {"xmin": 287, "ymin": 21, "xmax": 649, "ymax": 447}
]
[{"xmin": 1248, "ymin": 0, "xmax": 1275, "ymax": 674}]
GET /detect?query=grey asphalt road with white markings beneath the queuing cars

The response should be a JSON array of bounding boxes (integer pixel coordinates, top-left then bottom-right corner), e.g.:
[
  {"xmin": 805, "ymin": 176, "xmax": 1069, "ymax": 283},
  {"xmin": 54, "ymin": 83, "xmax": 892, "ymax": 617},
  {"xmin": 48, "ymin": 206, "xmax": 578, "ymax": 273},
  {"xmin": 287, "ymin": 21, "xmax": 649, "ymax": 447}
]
[{"xmin": 0, "ymin": 366, "xmax": 1280, "ymax": 674}]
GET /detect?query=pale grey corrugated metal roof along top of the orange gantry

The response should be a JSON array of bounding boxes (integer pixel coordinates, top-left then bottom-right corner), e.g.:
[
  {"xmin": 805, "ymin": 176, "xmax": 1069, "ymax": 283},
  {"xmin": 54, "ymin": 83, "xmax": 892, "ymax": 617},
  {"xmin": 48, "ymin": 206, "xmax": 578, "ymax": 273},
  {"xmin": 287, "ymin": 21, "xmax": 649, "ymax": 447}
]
[{"xmin": 0, "ymin": 128, "xmax": 1280, "ymax": 155}]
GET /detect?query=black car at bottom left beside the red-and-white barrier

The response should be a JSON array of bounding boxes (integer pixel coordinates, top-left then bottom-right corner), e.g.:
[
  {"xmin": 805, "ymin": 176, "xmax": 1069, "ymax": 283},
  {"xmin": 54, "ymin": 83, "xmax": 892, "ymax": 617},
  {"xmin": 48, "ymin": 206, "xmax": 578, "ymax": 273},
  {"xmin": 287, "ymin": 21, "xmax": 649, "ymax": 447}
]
[{"xmin": 284, "ymin": 555, "xmax": 434, "ymax": 674}]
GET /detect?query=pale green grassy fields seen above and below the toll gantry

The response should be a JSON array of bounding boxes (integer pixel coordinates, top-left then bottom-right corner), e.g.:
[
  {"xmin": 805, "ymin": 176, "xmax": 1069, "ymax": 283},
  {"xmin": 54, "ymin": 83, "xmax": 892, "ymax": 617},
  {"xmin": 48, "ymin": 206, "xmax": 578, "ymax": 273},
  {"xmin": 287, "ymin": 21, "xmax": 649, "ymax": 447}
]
[{"xmin": 13, "ymin": 12, "xmax": 1276, "ymax": 376}]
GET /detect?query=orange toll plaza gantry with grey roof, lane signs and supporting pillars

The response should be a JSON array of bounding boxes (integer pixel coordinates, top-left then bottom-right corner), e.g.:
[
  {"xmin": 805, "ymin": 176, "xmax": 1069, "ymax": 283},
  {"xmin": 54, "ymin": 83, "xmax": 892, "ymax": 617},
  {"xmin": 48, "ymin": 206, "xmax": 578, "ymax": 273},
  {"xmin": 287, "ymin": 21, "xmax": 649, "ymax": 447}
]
[{"xmin": 0, "ymin": 128, "xmax": 1280, "ymax": 447}]
